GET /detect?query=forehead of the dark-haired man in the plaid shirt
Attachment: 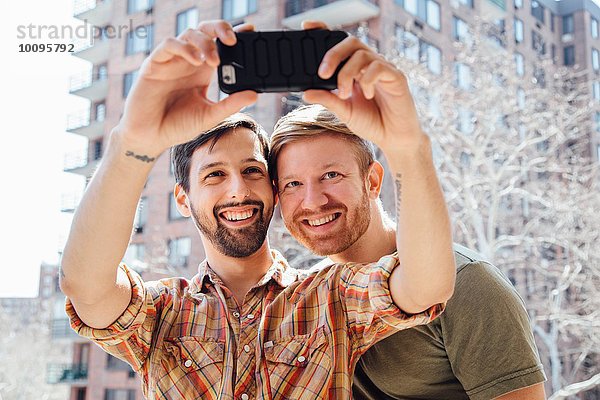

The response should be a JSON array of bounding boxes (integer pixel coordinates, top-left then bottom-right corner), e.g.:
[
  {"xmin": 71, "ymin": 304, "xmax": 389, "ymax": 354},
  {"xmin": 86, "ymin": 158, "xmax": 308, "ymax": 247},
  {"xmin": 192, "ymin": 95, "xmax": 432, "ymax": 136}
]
[{"xmin": 192, "ymin": 127, "xmax": 266, "ymax": 170}]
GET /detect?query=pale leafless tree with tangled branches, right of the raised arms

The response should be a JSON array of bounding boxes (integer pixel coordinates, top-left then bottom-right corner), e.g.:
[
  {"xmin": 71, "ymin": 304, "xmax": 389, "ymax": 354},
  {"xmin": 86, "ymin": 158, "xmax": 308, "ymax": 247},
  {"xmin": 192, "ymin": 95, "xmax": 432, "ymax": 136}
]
[{"xmin": 390, "ymin": 21, "xmax": 600, "ymax": 398}]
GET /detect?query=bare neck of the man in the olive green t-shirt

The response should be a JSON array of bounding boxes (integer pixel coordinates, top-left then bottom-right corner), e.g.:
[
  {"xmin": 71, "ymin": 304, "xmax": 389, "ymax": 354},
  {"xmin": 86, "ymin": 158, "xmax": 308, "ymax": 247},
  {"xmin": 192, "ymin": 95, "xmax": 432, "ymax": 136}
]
[{"xmin": 329, "ymin": 203, "xmax": 396, "ymax": 263}]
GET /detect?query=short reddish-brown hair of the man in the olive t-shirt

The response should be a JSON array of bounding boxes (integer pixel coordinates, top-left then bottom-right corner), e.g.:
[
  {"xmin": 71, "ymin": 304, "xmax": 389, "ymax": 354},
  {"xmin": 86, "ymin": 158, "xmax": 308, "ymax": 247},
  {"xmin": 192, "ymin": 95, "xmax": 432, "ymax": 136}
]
[{"xmin": 269, "ymin": 104, "xmax": 375, "ymax": 182}]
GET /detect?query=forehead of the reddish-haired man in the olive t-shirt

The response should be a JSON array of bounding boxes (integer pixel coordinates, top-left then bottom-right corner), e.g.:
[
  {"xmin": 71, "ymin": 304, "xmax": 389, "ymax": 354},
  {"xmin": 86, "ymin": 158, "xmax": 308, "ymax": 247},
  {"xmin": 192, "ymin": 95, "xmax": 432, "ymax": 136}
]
[{"xmin": 277, "ymin": 134, "xmax": 359, "ymax": 177}]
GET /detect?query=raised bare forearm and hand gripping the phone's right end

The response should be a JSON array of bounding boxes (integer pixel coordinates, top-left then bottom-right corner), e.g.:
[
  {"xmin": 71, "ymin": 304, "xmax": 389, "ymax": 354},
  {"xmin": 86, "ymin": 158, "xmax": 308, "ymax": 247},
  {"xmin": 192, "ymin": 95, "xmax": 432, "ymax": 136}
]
[{"xmin": 304, "ymin": 23, "xmax": 456, "ymax": 313}]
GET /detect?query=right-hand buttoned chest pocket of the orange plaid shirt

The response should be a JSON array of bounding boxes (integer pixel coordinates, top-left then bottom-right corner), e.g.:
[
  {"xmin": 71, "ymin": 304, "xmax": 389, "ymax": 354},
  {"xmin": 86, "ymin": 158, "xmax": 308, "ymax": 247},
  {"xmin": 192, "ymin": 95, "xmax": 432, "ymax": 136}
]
[{"xmin": 263, "ymin": 327, "xmax": 333, "ymax": 399}]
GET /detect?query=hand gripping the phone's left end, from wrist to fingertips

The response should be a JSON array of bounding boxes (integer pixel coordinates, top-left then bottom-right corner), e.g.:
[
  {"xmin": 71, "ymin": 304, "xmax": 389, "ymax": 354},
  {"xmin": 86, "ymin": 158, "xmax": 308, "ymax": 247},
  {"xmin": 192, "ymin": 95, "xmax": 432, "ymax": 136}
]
[{"xmin": 115, "ymin": 21, "xmax": 257, "ymax": 156}]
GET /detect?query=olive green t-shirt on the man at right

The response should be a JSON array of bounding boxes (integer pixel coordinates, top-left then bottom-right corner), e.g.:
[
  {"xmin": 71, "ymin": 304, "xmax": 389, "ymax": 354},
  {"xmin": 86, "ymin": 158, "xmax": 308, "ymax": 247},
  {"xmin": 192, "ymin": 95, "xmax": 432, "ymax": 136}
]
[{"xmin": 353, "ymin": 249, "xmax": 546, "ymax": 400}]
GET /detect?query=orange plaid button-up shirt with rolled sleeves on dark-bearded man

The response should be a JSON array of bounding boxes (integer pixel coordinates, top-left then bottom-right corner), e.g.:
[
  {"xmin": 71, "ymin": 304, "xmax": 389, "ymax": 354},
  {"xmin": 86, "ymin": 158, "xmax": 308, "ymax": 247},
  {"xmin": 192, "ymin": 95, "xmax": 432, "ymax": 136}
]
[{"xmin": 66, "ymin": 252, "xmax": 443, "ymax": 400}]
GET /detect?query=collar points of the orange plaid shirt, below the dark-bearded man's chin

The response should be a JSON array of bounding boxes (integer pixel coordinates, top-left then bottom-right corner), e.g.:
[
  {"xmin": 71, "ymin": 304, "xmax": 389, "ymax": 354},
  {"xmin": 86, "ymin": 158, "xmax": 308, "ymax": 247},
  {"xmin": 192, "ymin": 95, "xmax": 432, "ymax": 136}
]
[{"xmin": 190, "ymin": 250, "xmax": 299, "ymax": 293}]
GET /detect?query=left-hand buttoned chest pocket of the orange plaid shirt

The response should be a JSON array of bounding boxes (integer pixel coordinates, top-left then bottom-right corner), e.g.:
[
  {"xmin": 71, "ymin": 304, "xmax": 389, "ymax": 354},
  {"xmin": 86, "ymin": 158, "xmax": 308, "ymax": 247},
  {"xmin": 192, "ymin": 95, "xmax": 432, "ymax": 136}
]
[{"xmin": 156, "ymin": 337, "xmax": 224, "ymax": 399}]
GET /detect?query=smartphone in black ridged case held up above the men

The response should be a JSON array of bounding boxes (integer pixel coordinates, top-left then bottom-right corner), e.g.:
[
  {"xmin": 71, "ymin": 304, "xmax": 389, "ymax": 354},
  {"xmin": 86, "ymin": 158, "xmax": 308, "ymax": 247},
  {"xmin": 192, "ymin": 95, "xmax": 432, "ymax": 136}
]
[{"xmin": 217, "ymin": 29, "xmax": 348, "ymax": 93}]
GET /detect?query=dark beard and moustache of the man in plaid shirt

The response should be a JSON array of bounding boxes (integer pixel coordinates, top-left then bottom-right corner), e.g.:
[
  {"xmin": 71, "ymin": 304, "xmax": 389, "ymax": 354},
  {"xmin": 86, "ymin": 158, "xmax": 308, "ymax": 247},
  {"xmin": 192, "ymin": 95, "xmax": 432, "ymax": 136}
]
[{"xmin": 190, "ymin": 200, "xmax": 273, "ymax": 258}]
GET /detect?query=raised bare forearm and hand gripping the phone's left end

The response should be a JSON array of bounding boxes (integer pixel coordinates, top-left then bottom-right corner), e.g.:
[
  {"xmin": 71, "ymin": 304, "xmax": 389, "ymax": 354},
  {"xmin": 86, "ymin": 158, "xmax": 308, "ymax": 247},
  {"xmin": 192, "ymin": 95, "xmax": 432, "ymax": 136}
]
[{"xmin": 60, "ymin": 21, "xmax": 256, "ymax": 328}]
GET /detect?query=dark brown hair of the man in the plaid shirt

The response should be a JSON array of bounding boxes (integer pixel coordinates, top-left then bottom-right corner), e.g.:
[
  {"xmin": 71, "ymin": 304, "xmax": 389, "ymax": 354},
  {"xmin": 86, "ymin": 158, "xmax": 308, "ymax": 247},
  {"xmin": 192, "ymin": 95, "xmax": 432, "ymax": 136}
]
[{"xmin": 171, "ymin": 113, "xmax": 269, "ymax": 192}]
